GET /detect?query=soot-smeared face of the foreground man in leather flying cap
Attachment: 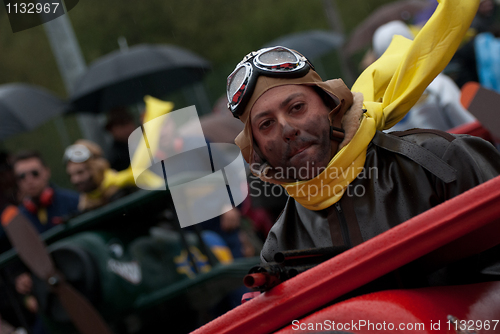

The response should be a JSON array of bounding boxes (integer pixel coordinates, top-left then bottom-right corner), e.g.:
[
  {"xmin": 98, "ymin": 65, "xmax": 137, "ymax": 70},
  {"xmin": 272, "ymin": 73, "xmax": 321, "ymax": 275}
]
[{"xmin": 250, "ymin": 85, "xmax": 331, "ymax": 180}]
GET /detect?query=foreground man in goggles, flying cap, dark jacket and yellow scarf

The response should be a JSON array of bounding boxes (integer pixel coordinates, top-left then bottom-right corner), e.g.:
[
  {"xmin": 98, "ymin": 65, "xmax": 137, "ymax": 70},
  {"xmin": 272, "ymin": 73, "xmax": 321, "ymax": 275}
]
[{"xmin": 227, "ymin": 0, "xmax": 500, "ymax": 284}]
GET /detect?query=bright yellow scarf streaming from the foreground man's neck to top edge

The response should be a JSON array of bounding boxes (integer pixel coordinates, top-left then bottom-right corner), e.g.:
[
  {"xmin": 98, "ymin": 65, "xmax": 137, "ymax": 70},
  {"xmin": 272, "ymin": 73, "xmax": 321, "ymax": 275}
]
[{"xmin": 283, "ymin": 0, "xmax": 479, "ymax": 210}]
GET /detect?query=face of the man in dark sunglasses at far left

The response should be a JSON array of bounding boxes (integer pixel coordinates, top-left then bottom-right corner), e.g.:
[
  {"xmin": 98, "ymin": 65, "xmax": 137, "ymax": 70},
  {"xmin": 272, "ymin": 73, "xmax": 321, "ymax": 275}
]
[{"xmin": 14, "ymin": 158, "xmax": 50, "ymax": 198}]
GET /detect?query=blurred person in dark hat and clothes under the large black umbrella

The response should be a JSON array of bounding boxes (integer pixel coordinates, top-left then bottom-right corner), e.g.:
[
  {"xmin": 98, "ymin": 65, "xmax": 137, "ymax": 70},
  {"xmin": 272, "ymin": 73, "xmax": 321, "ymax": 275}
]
[{"xmin": 106, "ymin": 107, "xmax": 137, "ymax": 171}]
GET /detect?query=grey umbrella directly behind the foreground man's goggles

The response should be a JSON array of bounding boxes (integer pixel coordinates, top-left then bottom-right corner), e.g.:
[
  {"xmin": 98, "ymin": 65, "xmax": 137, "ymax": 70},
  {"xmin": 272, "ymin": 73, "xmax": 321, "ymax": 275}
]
[{"xmin": 265, "ymin": 30, "xmax": 344, "ymax": 60}]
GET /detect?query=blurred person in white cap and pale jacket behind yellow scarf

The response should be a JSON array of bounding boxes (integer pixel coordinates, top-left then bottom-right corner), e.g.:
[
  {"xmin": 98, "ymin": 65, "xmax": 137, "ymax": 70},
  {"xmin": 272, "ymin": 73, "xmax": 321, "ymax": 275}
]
[{"xmin": 373, "ymin": 21, "xmax": 475, "ymax": 131}]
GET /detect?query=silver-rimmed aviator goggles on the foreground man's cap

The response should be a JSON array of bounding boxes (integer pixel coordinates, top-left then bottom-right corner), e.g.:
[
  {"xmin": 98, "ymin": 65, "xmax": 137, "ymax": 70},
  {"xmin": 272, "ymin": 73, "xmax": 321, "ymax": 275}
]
[{"xmin": 226, "ymin": 46, "xmax": 314, "ymax": 118}]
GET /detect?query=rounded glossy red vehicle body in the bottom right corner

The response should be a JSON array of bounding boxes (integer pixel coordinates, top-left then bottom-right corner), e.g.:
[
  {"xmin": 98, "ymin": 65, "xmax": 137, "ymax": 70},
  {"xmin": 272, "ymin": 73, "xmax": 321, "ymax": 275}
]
[{"xmin": 277, "ymin": 282, "xmax": 500, "ymax": 334}]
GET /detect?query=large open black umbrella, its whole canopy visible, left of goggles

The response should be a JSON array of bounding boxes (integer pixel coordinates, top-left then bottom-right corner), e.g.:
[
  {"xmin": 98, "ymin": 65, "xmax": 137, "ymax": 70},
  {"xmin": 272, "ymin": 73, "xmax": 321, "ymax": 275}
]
[{"xmin": 70, "ymin": 44, "xmax": 210, "ymax": 112}]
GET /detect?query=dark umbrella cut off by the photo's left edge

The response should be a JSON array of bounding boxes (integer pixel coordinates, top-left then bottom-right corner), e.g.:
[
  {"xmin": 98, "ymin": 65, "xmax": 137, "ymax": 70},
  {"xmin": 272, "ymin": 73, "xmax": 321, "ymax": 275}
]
[{"xmin": 0, "ymin": 84, "xmax": 67, "ymax": 140}]
